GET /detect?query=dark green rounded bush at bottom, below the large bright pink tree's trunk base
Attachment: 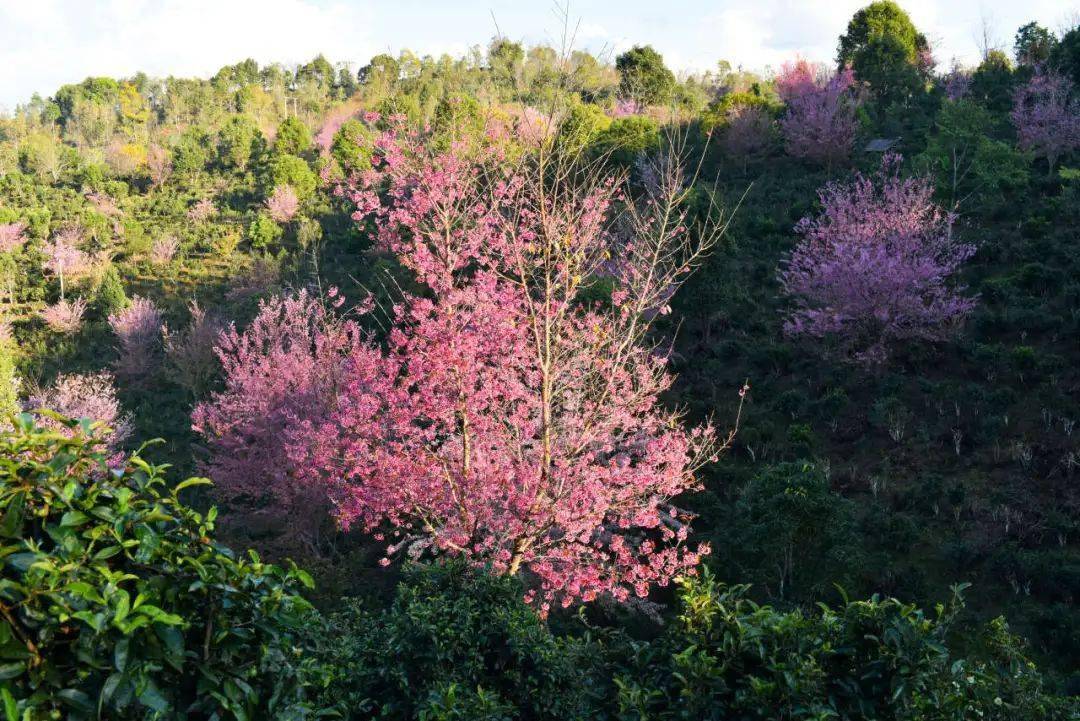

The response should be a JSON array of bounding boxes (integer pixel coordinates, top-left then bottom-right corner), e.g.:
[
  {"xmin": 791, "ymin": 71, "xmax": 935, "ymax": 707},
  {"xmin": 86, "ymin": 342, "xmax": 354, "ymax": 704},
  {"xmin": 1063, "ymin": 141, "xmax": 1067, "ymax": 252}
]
[{"xmin": 322, "ymin": 563, "xmax": 584, "ymax": 721}]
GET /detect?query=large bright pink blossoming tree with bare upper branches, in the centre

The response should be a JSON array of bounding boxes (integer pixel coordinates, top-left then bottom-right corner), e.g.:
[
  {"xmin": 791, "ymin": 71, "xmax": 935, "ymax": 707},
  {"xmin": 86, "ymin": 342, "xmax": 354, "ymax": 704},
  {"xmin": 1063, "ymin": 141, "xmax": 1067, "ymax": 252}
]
[{"xmin": 274, "ymin": 122, "xmax": 721, "ymax": 609}]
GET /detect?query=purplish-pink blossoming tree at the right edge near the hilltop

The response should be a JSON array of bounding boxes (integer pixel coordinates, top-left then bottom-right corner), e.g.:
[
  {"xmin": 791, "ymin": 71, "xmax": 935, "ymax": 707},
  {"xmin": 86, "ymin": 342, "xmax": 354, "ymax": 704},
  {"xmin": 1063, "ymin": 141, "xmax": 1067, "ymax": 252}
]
[{"xmin": 1012, "ymin": 69, "xmax": 1080, "ymax": 174}]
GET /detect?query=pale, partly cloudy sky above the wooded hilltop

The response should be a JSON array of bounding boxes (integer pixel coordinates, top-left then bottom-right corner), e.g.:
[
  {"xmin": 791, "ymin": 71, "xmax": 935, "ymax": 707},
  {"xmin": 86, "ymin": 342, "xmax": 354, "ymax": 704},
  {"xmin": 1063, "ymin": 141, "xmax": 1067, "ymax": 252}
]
[{"xmin": 0, "ymin": 0, "xmax": 1080, "ymax": 110}]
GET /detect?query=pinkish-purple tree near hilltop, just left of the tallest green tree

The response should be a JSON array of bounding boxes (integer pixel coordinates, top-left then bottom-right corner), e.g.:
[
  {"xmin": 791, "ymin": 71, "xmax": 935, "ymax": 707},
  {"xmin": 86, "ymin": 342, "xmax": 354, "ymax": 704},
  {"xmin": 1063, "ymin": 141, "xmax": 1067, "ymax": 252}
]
[{"xmin": 775, "ymin": 60, "xmax": 858, "ymax": 165}]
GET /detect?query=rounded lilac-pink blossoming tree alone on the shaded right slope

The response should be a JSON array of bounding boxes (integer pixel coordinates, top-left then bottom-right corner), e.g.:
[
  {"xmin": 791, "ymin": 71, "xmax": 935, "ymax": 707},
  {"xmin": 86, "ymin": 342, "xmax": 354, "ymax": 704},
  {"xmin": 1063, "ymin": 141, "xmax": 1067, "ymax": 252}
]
[{"xmin": 780, "ymin": 155, "xmax": 975, "ymax": 365}]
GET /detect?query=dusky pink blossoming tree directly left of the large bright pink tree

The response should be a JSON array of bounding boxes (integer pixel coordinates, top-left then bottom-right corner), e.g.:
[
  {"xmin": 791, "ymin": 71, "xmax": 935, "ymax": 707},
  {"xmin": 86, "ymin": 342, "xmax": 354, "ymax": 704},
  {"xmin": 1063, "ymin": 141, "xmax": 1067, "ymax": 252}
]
[{"xmin": 192, "ymin": 291, "xmax": 360, "ymax": 550}]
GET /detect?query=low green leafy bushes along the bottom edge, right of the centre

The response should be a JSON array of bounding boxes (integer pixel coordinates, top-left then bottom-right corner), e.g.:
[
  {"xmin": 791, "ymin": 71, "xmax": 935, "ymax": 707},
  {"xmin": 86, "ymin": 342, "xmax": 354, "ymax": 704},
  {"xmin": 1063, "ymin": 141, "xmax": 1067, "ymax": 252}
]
[{"xmin": 616, "ymin": 573, "xmax": 1075, "ymax": 721}]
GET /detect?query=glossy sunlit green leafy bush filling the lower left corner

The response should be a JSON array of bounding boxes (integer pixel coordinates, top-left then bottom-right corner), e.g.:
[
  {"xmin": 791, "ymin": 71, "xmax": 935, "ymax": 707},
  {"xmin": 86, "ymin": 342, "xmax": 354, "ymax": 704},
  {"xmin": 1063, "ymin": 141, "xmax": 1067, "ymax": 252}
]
[{"xmin": 0, "ymin": 416, "xmax": 313, "ymax": 720}]
